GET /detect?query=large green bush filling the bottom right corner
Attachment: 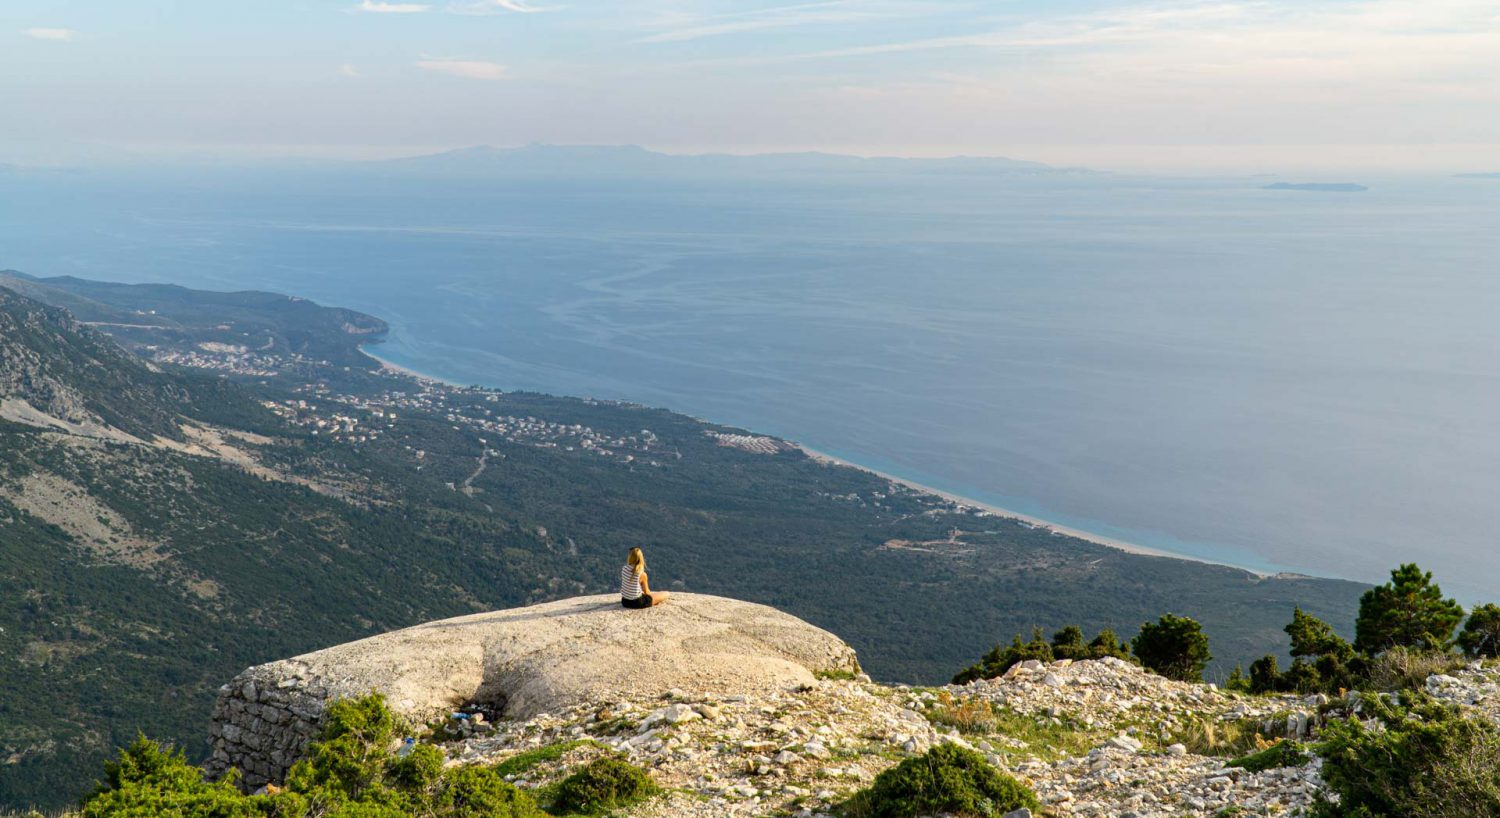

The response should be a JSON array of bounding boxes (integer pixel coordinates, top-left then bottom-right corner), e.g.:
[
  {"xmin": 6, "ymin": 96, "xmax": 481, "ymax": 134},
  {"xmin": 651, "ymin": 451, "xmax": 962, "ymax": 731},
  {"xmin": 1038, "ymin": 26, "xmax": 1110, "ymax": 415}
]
[{"xmin": 1317, "ymin": 692, "xmax": 1500, "ymax": 818}]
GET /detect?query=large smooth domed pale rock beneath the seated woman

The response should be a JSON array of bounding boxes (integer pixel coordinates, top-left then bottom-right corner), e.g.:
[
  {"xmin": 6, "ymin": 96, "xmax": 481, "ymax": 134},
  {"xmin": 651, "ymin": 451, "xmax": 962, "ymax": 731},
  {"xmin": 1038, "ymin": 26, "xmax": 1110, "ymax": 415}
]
[{"xmin": 209, "ymin": 593, "xmax": 858, "ymax": 786}]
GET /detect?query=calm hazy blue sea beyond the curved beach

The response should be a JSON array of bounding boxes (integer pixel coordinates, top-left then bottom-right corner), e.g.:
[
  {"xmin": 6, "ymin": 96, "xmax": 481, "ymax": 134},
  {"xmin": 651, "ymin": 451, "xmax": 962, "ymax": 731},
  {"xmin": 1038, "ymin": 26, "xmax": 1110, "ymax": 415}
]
[{"xmin": 0, "ymin": 165, "xmax": 1500, "ymax": 600}]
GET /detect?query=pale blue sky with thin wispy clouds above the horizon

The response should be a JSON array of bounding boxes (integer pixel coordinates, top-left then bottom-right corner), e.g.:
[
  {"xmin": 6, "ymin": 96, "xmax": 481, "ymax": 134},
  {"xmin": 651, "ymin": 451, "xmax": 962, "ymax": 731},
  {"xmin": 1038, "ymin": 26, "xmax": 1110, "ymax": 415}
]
[{"xmin": 0, "ymin": 0, "xmax": 1500, "ymax": 171}]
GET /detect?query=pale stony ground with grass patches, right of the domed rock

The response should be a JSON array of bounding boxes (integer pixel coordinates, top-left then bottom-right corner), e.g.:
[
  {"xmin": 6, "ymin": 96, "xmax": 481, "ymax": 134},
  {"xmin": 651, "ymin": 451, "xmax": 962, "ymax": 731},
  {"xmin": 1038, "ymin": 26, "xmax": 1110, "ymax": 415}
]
[{"xmin": 435, "ymin": 659, "xmax": 1338, "ymax": 818}]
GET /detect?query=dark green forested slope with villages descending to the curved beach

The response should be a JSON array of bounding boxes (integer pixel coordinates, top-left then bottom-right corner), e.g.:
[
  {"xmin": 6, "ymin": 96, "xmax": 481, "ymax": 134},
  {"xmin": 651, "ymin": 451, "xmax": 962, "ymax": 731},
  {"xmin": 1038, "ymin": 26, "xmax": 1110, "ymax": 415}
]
[{"xmin": 0, "ymin": 277, "xmax": 1362, "ymax": 806}]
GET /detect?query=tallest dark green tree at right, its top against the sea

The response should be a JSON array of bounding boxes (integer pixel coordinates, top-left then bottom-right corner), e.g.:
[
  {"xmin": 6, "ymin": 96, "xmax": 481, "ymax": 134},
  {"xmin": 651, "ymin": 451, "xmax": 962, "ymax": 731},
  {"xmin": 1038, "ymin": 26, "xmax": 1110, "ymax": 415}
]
[{"xmin": 1355, "ymin": 563, "xmax": 1464, "ymax": 656}]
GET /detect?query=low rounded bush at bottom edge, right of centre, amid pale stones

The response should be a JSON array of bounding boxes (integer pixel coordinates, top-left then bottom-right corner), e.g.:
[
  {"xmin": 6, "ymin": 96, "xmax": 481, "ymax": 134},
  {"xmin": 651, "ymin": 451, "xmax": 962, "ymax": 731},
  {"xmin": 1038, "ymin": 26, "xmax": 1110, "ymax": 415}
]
[{"xmin": 840, "ymin": 744, "xmax": 1041, "ymax": 818}]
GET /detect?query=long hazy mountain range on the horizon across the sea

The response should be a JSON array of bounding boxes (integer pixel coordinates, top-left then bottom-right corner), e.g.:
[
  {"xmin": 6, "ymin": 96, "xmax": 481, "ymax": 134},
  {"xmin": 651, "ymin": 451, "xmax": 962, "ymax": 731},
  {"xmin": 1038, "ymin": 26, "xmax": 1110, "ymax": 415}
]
[{"xmin": 366, "ymin": 144, "xmax": 1092, "ymax": 176}]
